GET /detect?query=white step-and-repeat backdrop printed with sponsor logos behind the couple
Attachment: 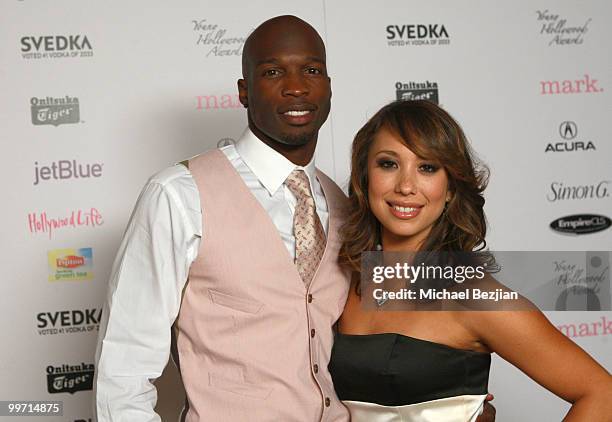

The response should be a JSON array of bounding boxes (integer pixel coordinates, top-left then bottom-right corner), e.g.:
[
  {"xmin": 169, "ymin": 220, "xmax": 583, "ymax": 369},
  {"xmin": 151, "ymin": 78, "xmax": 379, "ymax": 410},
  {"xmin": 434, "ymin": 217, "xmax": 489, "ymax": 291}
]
[{"xmin": 0, "ymin": 0, "xmax": 612, "ymax": 422}]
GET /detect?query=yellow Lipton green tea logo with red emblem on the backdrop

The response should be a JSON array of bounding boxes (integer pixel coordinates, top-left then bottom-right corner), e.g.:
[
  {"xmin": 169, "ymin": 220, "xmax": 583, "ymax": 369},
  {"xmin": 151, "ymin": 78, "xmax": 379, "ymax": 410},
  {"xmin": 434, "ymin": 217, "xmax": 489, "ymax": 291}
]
[{"xmin": 47, "ymin": 248, "xmax": 94, "ymax": 281}]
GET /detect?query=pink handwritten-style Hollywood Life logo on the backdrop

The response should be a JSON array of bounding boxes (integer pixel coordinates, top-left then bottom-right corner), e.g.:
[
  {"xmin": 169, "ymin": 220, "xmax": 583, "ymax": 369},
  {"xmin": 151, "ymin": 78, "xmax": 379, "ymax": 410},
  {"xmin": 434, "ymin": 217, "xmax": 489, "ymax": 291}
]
[{"xmin": 28, "ymin": 208, "xmax": 104, "ymax": 239}]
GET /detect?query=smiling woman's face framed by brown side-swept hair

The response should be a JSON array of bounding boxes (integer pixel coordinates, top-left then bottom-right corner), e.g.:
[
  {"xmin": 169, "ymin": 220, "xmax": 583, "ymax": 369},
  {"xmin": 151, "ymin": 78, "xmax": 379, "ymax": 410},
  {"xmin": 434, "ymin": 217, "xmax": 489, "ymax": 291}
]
[{"xmin": 368, "ymin": 128, "xmax": 451, "ymax": 251}]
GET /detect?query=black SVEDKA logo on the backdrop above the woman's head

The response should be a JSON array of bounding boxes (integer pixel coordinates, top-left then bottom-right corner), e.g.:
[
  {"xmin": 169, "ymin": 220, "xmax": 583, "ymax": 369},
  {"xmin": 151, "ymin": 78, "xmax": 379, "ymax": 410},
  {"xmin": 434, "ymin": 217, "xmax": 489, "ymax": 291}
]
[{"xmin": 386, "ymin": 24, "xmax": 450, "ymax": 47}]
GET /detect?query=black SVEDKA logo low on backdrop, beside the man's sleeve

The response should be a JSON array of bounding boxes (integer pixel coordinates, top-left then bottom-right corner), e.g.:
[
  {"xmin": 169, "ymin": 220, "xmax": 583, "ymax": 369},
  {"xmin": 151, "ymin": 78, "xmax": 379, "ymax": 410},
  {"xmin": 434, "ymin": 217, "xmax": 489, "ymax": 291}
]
[{"xmin": 36, "ymin": 308, "xmax": 102, "ymax": 336}]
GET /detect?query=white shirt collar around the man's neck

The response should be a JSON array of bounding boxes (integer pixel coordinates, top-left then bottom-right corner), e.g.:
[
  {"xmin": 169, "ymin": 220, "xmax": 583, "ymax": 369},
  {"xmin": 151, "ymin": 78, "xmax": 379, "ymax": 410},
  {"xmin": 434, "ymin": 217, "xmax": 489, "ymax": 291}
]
[{"xmin": 236, "ymin": 127, "xmax": 316, "ymax": 196}]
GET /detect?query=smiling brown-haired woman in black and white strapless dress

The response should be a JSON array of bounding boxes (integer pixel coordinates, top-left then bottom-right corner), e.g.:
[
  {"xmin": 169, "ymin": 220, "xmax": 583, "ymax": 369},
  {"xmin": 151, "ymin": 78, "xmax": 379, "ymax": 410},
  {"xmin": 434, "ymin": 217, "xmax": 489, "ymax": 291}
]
[{"xmin": 329, "ymin": 101, "xmax": 612, "ymax": 422}]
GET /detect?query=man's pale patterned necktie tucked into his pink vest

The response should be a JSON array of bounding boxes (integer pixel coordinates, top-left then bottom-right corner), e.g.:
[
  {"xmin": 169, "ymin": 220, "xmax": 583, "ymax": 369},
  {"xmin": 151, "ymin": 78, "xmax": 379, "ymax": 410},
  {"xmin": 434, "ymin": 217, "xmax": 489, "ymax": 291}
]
[{"xmin": 285, "ymin": 170, "xmax": 325, "ymax": 286}]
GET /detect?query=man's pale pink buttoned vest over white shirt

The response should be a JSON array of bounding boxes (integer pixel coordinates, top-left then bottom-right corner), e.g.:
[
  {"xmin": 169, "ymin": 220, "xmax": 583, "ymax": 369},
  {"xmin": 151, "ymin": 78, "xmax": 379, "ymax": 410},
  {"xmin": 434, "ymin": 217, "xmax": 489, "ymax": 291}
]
[{"xmin": 175, "ymin": 150, "xmax": 349, "ymax": 422}]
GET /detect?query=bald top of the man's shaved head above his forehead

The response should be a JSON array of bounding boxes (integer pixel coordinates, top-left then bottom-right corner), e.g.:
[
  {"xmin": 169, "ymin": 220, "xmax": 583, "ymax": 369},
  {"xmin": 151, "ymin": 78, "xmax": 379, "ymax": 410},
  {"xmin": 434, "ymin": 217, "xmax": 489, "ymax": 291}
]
[{"xmin": 242, "ymin": 15, "xmax": 325, "ymax": 79}]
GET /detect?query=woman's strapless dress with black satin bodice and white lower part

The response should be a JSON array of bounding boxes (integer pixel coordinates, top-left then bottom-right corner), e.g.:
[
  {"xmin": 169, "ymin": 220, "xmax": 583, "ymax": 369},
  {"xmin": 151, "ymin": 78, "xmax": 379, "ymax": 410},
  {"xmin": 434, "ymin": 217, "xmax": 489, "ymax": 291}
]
[{"xmin": 329, "ymin": 333, "xmax": 491, "ymax": 422}]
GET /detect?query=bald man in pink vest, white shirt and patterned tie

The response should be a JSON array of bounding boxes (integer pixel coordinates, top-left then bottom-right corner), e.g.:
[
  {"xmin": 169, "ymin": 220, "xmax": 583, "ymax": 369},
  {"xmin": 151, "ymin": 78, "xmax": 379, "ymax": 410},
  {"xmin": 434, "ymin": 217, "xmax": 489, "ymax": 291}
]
[{"xmin": 95, "ymin": 16, "xmax": 498, "ymax": 422}]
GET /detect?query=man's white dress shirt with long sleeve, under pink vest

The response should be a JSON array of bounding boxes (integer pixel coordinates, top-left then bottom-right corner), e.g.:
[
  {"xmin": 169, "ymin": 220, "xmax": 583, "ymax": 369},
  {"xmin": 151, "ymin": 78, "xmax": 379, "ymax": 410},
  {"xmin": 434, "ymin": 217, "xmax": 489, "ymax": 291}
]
[{"xmin": 94, "ymin": 129, "xmax": 328, "ymax": 422}]
